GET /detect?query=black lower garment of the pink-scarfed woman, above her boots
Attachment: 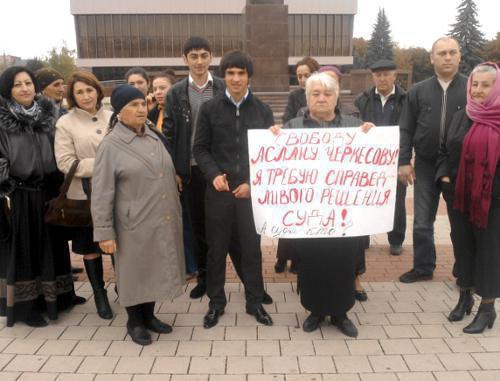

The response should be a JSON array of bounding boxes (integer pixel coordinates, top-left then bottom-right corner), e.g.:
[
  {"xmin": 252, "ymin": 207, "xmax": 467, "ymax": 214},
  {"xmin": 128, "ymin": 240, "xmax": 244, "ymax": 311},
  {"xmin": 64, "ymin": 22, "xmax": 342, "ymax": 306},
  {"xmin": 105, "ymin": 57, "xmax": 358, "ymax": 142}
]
[{"xmin": 443, "ymin": 184, "xmax": 500, "ymax": 298}]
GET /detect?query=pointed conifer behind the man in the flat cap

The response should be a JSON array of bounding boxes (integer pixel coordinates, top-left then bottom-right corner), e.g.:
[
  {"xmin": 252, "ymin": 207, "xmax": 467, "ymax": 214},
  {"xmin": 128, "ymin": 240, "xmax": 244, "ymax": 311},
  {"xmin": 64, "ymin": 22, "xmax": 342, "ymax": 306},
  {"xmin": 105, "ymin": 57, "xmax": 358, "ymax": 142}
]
[{"xmin": 366, "ymin": 8, "xmax": 393, "ymax": 66}]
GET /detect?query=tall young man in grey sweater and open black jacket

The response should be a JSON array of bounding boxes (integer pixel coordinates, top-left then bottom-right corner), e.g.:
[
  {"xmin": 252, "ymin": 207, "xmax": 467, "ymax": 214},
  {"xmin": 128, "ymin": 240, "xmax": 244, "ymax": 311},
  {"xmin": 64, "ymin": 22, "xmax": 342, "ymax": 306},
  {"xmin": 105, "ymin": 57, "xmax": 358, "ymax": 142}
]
[{"xmin": 162, "ymin": 37, "xmax": 272, "ymax": 304}]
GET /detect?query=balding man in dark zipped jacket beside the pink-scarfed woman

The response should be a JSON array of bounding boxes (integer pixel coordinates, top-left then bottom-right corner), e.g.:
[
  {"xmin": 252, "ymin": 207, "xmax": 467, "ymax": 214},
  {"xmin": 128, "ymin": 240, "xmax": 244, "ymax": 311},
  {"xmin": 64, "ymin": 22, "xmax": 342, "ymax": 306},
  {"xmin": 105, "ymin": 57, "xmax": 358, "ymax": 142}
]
[{"xmin": 399, "ymin": 37, "xmax": 467, "ymax": 283}]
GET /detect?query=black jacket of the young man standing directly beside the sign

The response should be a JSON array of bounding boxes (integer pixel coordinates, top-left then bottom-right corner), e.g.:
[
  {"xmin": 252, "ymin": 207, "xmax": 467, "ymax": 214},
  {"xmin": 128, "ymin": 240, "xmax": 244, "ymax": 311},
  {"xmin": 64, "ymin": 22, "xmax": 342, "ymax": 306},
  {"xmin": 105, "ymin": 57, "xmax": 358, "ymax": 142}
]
[{"xmin": 193, "ymin": 92, "xmax": 274, "ymax": 189}]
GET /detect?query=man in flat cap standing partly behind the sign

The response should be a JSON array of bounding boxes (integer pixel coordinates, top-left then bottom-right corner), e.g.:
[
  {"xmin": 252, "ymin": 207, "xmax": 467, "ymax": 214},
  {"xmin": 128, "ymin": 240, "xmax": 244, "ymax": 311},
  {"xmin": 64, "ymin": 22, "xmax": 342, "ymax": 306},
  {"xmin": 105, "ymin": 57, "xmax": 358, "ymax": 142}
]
[{"xmin": 354, "ymin": 60, "xmax": 406, "ymax": 255}]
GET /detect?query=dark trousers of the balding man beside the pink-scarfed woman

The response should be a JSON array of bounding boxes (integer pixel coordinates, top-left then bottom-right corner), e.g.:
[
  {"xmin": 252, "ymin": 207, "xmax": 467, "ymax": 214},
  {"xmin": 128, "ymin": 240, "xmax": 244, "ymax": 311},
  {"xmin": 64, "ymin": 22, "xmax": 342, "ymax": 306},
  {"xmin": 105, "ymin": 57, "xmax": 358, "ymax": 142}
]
[{"xmin": 413, "ymin": 156, "xmax": 441, "ymax": 275}]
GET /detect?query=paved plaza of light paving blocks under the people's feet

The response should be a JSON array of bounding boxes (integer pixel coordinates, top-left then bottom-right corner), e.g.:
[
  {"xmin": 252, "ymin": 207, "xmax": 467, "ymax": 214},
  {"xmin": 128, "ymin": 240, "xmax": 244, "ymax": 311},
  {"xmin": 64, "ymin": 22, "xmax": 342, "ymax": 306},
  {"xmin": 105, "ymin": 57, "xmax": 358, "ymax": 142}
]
[{"xmin": 0, "ymin": 196, "xmax": 500, "ymax": 381}]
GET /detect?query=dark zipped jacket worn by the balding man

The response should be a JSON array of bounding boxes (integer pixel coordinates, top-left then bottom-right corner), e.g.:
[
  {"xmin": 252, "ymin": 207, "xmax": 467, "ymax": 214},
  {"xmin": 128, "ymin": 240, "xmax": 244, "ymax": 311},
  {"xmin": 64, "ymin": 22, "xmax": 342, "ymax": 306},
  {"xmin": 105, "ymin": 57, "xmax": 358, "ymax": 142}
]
[{"xmin": 399, "ymin": 74, "xmax": 467, "ymax": 165}]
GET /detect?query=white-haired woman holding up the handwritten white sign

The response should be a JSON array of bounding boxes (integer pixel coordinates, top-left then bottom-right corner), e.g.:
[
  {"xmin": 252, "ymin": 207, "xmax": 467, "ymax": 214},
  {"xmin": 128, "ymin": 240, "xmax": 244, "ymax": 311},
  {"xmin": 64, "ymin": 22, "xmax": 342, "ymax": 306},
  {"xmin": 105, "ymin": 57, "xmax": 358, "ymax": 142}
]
[{"xmin": 271, "ymin": 73, "xmax": 373, "ymax": 337}]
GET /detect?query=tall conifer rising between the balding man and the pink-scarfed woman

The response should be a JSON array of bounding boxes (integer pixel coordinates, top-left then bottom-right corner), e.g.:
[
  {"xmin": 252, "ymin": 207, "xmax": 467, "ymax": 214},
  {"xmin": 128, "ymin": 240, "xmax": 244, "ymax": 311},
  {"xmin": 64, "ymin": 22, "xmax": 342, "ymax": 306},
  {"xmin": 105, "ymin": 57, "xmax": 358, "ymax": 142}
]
[{"xmin": 448, "ymin": 0, "xmax": 484, "ymax": 75}]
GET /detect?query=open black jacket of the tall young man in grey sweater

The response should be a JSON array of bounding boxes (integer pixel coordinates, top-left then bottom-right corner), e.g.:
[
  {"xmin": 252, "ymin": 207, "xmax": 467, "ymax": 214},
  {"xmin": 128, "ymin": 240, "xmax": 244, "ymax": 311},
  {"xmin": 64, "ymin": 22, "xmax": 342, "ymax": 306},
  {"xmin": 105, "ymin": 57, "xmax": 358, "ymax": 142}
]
[{"xmin": 162, "ymin": 77, "xmax": 225, "ymax": 181}]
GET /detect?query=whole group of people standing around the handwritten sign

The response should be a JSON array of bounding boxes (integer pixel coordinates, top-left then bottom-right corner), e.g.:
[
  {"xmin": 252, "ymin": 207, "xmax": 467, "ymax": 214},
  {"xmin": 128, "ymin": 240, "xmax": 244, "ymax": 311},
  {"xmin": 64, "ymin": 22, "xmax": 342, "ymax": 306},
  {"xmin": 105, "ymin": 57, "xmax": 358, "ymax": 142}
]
[{"xmin": 0, "ymin": 33, "xmax": 500, "ymax": 345}]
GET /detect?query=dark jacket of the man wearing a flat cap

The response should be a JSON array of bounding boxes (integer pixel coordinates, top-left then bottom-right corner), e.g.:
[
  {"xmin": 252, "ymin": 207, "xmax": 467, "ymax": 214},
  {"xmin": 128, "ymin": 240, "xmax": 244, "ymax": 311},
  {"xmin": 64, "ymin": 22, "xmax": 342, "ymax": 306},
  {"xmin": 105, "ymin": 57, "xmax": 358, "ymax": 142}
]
[{"xmin": 354, "ymin": 85, "xmax": 406, "ymax": 126}]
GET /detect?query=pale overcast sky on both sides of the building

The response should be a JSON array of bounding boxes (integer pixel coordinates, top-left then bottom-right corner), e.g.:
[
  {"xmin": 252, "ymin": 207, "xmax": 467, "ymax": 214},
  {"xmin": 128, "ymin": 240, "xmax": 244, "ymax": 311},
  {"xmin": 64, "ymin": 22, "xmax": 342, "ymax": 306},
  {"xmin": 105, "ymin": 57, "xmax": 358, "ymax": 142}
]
[{"xmin": 0, "ymin": 0, "xmax": 500, "ymax": 58}]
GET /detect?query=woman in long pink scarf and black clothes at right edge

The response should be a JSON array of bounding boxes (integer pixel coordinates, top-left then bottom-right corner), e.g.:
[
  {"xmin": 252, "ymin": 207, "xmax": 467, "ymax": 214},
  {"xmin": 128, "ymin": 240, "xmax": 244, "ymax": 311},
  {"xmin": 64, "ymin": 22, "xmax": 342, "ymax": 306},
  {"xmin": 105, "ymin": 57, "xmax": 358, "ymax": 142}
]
[{"xmin": 436, "ymin": 62, "xmax": 500, "ymax": 333}]
